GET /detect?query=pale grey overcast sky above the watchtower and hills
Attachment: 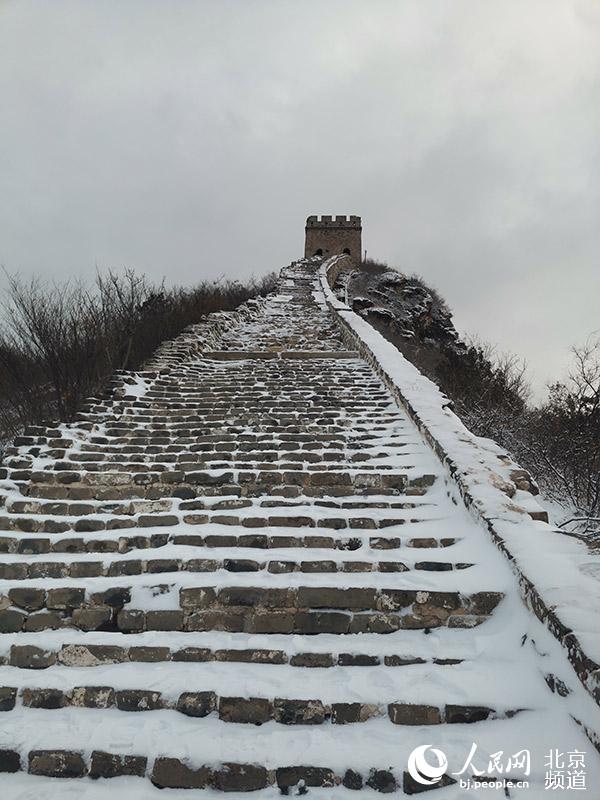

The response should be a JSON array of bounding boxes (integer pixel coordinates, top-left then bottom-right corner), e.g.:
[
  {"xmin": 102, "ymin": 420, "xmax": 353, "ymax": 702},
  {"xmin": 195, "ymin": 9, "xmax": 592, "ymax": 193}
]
[{"xmin": 0, "ymin": 0, "xmax": 600, "ymax": 400}]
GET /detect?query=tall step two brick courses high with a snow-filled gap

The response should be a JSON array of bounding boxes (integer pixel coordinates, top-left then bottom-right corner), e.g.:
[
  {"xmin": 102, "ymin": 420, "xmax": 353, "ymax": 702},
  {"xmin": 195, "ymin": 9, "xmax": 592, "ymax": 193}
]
[{"xmin": 0, "ymin": 584, "xmax": 503, "ymax": 635}]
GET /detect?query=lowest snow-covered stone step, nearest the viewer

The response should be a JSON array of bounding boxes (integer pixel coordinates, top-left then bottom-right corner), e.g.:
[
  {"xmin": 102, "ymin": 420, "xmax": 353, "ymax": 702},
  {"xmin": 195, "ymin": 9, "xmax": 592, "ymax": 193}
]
[{"xmin": 3, "ymin": 708, "xmax": 600, "ymax": 798}]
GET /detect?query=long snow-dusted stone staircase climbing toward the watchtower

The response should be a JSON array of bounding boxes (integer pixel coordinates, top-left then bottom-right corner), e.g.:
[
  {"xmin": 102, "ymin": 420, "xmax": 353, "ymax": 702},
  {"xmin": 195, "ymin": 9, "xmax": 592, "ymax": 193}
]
[{"xmin": 0, "ymin": 260, "xmax": 589, "ymax": 797}]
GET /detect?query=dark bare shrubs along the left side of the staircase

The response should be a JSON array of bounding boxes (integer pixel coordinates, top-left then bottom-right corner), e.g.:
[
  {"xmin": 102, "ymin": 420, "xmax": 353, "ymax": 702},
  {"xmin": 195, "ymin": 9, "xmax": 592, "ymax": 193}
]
[{"xmin": 0, "ymin": 270, "xmax": 276, "ymax": 446}]
